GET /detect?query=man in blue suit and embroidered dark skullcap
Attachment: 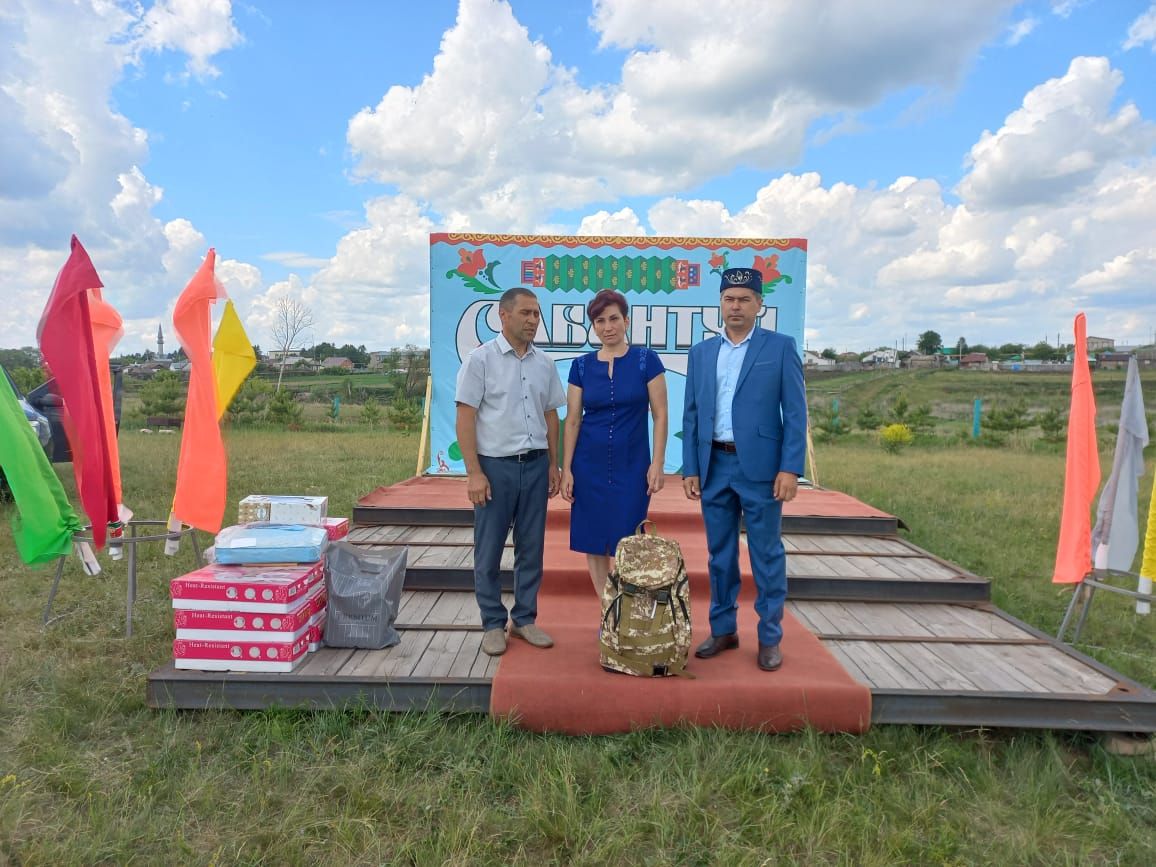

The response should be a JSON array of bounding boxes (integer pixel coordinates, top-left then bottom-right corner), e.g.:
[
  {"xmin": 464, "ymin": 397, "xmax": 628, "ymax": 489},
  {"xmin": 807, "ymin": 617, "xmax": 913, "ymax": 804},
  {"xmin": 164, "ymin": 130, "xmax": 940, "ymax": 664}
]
[{"xmin": 682, "ymin": 268, "xmax": 807, "ymax": 672}]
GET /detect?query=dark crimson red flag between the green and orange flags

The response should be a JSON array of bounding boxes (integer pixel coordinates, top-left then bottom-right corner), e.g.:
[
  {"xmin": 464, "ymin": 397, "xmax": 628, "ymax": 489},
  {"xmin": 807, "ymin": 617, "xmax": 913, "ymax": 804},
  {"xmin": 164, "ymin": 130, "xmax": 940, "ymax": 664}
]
[{"xmin": 37, "ymin": 235, "xmax": 118, "ymax": 548}]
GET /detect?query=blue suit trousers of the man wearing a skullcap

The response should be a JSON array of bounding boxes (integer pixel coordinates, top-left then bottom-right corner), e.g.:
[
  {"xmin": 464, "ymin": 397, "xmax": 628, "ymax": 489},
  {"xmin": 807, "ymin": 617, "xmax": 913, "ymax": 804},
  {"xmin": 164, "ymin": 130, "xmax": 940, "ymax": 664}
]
[{"xmin": 703, "ymin": 450, "xmax": 787, "ymax": 645}]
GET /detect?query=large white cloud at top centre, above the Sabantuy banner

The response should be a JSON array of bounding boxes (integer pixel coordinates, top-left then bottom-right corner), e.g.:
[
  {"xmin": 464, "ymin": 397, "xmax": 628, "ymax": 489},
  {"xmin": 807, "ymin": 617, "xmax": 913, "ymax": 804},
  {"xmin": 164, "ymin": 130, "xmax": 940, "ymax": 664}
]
[{"xmin": 347, "ymin": 0, "xmax": 1014, "ymax": 230}]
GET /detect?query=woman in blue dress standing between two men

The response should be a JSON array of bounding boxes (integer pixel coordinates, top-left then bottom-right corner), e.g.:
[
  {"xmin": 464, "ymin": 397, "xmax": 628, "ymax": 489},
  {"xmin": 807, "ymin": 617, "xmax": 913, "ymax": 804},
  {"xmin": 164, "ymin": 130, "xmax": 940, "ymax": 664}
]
[{"xmin": 562, "ymin": 289, "xmax": 668, "ymax": 595}]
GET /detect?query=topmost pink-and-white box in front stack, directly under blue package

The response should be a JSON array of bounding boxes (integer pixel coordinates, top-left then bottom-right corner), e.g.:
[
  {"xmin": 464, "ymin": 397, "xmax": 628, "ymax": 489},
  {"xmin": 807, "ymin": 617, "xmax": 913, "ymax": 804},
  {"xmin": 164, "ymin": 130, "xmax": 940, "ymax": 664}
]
[{"xmin": 169, "ymin": 561, "xmax": 325, "ymax": 614}]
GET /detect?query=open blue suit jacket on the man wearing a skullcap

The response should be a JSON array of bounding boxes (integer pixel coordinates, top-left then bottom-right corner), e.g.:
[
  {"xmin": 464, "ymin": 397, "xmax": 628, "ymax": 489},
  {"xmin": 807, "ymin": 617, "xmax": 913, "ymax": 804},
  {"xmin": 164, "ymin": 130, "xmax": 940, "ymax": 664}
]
[{"xmin": 682, "ymin": 326, "xmax": 807, "ymax": 484}]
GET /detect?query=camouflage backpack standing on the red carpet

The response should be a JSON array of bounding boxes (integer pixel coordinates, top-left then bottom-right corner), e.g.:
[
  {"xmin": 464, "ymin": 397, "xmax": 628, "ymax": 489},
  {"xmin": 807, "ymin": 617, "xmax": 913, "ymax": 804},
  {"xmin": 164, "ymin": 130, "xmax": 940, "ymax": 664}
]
[{"xmin": 599, "ymin": 521, "xmax": 694, "ymax": 677}]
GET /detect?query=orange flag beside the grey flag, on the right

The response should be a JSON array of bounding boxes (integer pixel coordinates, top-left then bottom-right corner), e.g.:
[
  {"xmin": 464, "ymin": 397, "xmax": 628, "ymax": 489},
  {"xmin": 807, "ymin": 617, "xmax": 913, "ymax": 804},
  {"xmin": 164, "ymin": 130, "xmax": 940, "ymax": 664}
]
[{"xmin": 1052, "ymin": 313, "xmax": 1099, "ymax": 584}]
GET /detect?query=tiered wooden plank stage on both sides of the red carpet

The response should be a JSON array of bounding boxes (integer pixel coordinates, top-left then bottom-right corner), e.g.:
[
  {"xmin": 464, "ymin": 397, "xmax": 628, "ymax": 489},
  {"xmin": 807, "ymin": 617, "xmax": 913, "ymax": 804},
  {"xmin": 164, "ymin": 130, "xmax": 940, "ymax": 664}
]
[{"xmin": 148, "ymin": 480, "xmax": 1156, "ymax": 733}]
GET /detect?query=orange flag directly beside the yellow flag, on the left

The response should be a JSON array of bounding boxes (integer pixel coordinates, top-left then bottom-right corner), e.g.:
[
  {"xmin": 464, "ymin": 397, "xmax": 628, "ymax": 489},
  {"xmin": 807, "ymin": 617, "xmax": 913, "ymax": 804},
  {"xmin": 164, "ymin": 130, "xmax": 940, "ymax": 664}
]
[{"xmin": 170, "ymin": 249, "xmax": 225, "ymax": 533}]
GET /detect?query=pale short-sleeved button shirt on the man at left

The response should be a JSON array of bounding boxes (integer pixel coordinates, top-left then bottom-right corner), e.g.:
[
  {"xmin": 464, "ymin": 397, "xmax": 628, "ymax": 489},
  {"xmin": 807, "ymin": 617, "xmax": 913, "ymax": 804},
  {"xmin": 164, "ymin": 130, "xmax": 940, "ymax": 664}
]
[{"xmin": 454, "ymin": 334, "xmax": 566, "ymax": 458}]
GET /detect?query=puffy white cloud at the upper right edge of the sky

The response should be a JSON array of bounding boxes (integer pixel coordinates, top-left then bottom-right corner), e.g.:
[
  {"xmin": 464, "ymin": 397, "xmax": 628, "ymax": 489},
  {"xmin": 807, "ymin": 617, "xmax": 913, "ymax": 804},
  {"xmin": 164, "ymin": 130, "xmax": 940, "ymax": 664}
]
[{"xmin": 959, "ymin": 57, "xmax": 1156, "ymax": 208}]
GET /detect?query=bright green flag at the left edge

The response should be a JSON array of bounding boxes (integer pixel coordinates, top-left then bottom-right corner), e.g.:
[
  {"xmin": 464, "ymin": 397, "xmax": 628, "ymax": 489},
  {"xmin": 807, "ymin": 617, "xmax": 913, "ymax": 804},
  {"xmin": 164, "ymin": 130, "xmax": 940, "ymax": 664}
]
[{"xmin": 0, "ymin": 375, "xmax": 81, "ymax": 564}]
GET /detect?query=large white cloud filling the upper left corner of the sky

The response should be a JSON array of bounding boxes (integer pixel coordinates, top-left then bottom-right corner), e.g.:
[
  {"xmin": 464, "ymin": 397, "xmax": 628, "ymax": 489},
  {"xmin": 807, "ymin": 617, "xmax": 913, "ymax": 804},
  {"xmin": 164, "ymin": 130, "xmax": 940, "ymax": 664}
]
[{"xmin": 0, "ymin": 0, "xmax": 243, "ymax": 349}]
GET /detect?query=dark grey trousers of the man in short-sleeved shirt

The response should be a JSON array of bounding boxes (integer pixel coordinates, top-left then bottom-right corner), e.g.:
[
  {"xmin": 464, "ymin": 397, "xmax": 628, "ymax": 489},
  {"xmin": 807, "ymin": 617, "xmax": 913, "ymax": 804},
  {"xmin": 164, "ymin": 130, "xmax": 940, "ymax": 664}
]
[{"xmin": 474, "ymin": 452, "xmax": 550, "ymax": 629}]
